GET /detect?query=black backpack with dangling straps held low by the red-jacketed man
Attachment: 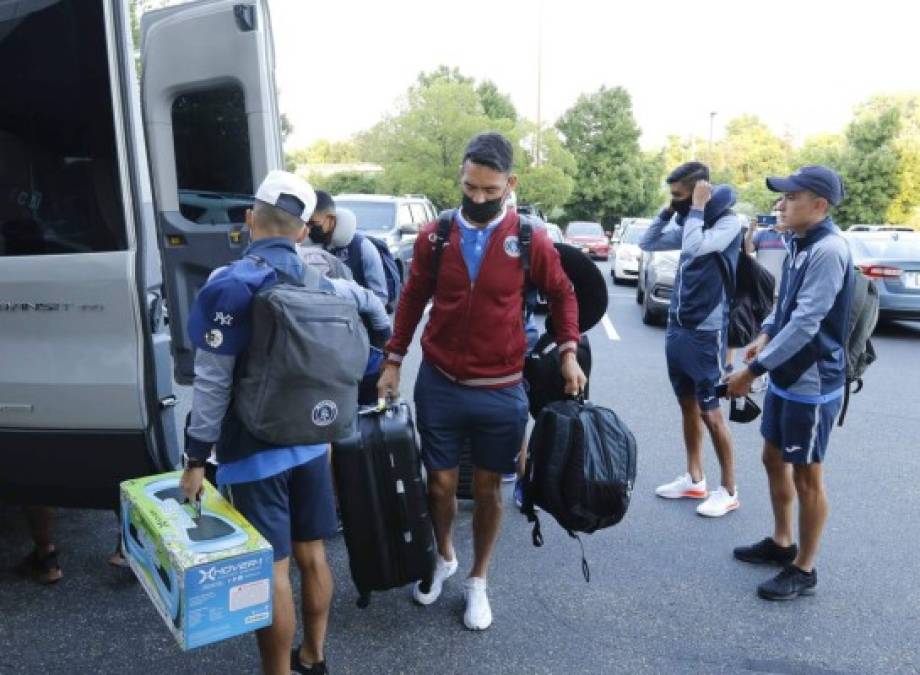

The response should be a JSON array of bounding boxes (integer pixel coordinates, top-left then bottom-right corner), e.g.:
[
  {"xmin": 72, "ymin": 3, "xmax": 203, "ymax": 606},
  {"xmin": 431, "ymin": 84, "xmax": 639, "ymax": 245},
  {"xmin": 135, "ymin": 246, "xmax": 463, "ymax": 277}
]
[{"xmin": 521, "ymin": 400, "xmax": 637, "ymax": 581}]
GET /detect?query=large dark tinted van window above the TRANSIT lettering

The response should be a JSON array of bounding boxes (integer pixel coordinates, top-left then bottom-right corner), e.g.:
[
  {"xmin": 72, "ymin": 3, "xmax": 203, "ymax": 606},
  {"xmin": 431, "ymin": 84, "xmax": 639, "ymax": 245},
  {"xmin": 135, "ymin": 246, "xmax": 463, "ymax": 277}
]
[{"xmin": 0, "ymin": 0, "xmax": 127, "ymax": 256}]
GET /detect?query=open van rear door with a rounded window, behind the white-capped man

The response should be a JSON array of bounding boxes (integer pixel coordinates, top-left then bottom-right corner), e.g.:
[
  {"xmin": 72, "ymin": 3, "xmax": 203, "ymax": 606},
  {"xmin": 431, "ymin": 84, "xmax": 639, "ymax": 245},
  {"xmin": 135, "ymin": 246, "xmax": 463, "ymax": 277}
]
[{"xmin": 141, "ymin": 0, "xmax": 283, "ymax": 383}]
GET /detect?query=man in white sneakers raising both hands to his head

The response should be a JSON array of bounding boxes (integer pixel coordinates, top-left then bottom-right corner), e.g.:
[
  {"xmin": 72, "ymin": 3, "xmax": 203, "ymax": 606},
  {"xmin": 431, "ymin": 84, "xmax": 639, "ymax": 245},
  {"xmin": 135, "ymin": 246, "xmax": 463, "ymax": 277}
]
[{"xmin": 639, "ymin": 162, "xmax": 743, "ymax": 517}]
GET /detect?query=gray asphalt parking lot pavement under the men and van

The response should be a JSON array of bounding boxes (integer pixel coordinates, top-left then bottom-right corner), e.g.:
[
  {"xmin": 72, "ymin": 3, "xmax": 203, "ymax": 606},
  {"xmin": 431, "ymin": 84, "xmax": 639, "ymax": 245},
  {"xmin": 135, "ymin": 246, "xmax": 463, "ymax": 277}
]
[{"xmin": 0, "ymin": 266, "xmax": 920, "ymax": 675}]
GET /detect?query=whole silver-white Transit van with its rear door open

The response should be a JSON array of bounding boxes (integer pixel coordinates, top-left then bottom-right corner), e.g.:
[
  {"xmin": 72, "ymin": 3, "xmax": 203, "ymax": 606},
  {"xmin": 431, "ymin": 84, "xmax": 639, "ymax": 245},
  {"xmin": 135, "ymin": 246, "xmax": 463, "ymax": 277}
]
[{"xmin": 0, "ymin": 0, "xmax": 283, "ymax": 508}]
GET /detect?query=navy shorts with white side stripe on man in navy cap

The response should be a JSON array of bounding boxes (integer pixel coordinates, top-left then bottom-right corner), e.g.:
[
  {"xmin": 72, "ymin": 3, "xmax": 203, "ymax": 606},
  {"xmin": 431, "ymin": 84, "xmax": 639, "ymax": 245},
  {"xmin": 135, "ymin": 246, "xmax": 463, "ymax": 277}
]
[{"xmin": 760, "ymin": 391, "xmax": 843, "ymax": 464}]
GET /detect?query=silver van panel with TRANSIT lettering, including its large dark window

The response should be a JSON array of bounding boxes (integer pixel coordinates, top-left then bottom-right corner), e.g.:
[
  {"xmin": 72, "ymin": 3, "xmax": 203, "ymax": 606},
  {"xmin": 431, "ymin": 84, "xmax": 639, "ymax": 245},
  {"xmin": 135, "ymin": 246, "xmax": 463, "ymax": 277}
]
[{"xmin": 0, "ymin": 0, "xmax": 178, "ymax": 506}]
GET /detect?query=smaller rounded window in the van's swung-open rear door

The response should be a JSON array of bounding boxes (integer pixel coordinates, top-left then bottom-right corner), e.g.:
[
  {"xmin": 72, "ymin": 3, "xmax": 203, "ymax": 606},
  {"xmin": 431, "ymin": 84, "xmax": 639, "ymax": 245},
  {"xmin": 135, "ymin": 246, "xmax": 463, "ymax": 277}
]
[{"xmin": 172, "ymin": 85, "xmax": 254, "ymax": 224}]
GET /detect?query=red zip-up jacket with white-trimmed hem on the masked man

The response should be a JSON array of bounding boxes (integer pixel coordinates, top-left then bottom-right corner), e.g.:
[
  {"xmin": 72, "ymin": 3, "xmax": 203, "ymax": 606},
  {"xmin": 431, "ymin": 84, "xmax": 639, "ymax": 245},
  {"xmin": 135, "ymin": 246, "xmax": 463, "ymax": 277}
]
[{"xmin": 386, "ymin": 211, "xmax": 579, "ymax": 388}]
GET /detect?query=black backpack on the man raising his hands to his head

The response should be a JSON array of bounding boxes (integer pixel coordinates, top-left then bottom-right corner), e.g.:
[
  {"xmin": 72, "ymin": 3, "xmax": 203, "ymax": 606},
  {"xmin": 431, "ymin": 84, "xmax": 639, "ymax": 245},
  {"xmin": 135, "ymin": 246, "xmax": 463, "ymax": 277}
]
[{"xmin": 716, "ymin": 251, "xmax": 776, "ymax": 347}]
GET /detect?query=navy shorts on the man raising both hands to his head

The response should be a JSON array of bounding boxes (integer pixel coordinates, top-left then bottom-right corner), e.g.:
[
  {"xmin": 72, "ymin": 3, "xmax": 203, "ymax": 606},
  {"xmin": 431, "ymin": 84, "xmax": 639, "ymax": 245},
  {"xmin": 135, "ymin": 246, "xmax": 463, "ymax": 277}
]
[{"xmin": 664, "ymin": 323, "xmax": 725, "ymax": 411}]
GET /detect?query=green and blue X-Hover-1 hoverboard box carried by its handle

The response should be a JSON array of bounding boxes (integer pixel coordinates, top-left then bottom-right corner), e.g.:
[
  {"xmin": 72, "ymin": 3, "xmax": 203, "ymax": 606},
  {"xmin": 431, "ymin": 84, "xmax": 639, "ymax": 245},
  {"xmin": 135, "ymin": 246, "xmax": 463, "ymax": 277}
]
[{"xmin": 121, "ymin": 471, "xmax": 273, "ymax": 649}]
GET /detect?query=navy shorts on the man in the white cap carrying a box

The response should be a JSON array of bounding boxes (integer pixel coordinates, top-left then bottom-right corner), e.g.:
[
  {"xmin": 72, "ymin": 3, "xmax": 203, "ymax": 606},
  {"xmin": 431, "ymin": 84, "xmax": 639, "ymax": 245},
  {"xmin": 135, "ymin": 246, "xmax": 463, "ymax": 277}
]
[{"xmin": 223, "ymin": 452, "xmax": 338, "ymax": 562}]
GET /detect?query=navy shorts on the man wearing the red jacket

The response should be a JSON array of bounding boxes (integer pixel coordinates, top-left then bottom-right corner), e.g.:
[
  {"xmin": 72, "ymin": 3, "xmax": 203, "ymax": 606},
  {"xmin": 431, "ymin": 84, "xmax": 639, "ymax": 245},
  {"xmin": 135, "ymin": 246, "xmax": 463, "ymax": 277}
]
[{"xmin": 415, "ymin": 361, "xmax": 527, "ymax": 474}]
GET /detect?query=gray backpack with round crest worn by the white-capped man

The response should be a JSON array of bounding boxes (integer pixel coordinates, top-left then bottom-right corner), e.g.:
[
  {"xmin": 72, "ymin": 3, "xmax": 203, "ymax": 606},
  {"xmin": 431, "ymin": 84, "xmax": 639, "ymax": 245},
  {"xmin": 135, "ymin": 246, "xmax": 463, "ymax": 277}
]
[{"xmin": 233, "ymin": 259, "xmax": 370, "ymax": 446}]
